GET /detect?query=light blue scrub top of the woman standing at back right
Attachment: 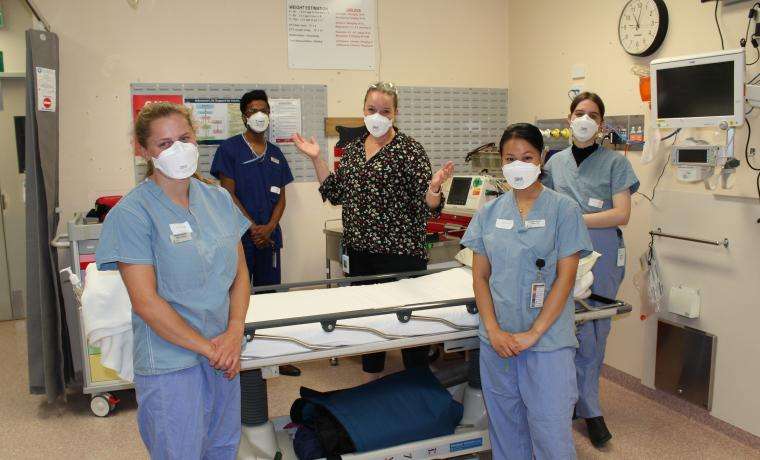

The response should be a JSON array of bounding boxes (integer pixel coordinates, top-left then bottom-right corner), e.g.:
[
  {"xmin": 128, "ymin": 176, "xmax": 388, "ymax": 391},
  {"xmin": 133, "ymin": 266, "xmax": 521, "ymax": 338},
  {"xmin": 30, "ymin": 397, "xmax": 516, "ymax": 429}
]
[{"xmin": 543, "ymin": 146, "xmax": 639, "ymax": 214}]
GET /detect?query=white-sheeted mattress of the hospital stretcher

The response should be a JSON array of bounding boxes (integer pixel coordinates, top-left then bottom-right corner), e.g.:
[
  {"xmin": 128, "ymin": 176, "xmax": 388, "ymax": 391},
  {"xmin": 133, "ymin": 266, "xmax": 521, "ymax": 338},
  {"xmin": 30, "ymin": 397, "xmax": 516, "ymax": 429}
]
[{"xmin": 243, "ymin": 267, "xmax": 479, "ymax": 358}]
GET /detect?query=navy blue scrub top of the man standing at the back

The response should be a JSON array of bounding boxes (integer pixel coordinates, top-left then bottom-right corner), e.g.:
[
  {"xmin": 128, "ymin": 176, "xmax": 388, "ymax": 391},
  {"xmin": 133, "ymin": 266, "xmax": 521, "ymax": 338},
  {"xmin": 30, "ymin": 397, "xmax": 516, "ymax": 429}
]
[{"xmin": 211, "ymin": 134, "xmax": 293, "ymax": 248}]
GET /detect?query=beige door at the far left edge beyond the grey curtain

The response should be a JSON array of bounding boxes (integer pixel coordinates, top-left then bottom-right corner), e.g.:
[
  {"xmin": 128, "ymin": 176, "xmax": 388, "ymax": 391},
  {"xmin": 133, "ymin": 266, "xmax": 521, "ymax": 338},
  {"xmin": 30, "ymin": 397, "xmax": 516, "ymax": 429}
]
[{"xmin": 0, "ymin": 78, "xmax": 26, "ymax": 320}]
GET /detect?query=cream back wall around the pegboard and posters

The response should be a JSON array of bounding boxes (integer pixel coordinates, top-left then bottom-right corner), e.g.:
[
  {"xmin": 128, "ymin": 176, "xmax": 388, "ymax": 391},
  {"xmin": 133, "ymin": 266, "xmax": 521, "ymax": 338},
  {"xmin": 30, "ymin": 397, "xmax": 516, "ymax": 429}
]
[{"xmin": 37, "ymin": 0, "xmax": 507, "ymax": 281}]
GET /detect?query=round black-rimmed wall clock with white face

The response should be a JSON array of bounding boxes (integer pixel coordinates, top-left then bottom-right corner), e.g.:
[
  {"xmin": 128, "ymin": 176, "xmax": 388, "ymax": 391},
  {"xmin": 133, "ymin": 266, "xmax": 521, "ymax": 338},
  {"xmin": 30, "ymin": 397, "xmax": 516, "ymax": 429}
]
[{"xmin": 618, "ymin": 0, "xmax": 668, "ymax": 56}]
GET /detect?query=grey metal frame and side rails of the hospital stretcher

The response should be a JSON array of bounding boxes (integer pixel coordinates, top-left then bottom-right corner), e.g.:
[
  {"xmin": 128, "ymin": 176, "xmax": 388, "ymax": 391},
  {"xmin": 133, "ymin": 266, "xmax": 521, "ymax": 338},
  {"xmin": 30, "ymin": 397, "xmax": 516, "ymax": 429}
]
[{"xmin": 238, "ymin": 268, "xmax": 632, "ymax": 460}]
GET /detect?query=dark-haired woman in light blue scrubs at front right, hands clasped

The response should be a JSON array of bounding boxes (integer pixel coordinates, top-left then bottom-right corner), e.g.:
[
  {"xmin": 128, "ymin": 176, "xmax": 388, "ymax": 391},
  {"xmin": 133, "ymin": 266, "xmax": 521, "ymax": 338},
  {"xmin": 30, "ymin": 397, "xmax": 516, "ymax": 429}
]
[{"xmin": 462, "ymin": 123, "xmax": 591, "ymax": 459}]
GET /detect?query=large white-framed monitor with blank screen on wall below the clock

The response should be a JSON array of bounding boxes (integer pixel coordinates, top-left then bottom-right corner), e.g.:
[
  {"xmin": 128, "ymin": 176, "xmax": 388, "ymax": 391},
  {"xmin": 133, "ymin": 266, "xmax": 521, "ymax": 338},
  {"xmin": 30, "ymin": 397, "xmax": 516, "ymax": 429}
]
[{"xmin": 650, "ymin": 50, "xmax": 745, "ymax": 129}]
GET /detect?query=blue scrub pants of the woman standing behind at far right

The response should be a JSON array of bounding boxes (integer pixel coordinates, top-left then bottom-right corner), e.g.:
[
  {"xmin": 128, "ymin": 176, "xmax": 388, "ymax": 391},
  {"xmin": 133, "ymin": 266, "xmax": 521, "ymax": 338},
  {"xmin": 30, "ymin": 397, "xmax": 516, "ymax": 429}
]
[{"xmin": 575, "ymin": 228, "xmax": 625, "ymax": 418}]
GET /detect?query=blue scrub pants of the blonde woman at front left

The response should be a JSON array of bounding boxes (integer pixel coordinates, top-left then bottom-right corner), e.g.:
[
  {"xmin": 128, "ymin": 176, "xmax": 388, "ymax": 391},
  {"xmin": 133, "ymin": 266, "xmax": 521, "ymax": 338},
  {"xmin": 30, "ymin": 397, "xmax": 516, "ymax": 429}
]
[{"xmin": 135, "ymin": 362, "xmax": 241, "ymax": 460}]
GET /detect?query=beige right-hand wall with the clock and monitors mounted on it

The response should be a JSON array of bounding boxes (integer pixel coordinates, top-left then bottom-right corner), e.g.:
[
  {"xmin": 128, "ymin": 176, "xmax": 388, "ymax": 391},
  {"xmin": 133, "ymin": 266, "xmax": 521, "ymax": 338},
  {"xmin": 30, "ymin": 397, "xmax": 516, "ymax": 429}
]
[{"xmin": 508, "ymin": 0, "xmax": 760, "ymax": 435}]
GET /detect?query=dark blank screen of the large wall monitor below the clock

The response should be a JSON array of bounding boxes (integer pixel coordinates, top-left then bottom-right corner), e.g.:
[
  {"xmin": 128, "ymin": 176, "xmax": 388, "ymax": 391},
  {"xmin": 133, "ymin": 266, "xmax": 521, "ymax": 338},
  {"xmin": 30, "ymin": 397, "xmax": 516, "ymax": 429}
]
[{"xmin": 657, "ymin": 61, "xmax": 734, "ymax": 118}]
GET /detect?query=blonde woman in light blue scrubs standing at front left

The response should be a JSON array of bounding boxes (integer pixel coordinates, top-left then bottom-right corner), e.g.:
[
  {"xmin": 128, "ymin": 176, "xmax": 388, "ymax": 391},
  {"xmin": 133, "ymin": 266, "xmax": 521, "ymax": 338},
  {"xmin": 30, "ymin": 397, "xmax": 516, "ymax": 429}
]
[{"xmin": 96, "ymin": 103, "xmax": 250, "ymax": 459}]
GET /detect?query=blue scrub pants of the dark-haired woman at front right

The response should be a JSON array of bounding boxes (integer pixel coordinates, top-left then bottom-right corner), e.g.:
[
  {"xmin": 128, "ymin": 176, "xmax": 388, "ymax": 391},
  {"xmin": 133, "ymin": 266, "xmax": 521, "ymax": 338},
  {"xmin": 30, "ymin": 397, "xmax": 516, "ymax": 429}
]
[{"xmin": 480, "ymin": 342, "xmax": 578, "ymax": 460}]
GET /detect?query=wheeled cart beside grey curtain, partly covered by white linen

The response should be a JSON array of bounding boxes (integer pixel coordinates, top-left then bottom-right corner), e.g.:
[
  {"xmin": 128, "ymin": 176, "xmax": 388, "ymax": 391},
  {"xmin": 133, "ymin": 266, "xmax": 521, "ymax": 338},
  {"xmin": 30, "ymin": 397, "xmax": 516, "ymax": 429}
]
[{"xmin": 51, "ymin": 213, "xmax": 134, "ymax": 417}]
